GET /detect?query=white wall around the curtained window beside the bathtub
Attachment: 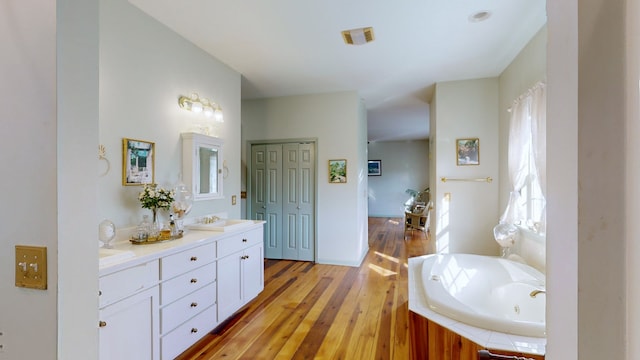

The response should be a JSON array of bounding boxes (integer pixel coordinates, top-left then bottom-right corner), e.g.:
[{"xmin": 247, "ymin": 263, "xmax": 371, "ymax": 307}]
[{"xmin": 499, "ymin": 26, "xmax": 547, "ymax": 272}]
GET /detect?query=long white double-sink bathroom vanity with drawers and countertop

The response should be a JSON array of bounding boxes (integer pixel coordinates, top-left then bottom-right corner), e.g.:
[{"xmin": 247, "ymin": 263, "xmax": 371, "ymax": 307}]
[{"xmin": 99, "ymin": 220, "xmax": 264, "ymax": 359}]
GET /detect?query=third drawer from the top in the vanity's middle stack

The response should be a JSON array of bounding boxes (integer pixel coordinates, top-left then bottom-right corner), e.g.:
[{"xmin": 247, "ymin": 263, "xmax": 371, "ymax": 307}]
[{"xmin": 160, "ymin": 282, "xmax": 216, "ymax": 334}]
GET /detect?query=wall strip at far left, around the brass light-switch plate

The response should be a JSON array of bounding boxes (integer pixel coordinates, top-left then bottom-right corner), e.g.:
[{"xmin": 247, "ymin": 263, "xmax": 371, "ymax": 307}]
[{"xmin": 0, "ymin": 0, "xmax": 58, "ymax": 360}]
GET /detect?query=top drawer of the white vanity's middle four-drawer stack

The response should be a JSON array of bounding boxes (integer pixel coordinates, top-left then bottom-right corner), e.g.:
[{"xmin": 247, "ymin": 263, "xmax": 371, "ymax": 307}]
[{"xmin": 160, "ymin": 243, "xmax": 216, "ymax": 280}]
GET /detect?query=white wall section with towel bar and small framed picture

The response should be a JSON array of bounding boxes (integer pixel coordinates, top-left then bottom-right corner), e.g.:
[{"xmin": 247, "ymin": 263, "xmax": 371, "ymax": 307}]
[{"xmin": 431, "ymin": 78, "xmax": 499, "ymax": 255}]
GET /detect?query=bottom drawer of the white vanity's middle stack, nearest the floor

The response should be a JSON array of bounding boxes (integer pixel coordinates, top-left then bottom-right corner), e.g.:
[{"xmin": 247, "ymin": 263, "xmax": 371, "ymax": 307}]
[{"xmin": 160, "ymin": 305, "xmax": 218, "ymax": 360}]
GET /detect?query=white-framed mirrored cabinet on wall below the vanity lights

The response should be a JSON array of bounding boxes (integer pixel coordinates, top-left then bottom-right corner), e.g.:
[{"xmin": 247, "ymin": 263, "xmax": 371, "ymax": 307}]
[{"xmin": 182, "ymin": 133, "xmax": 224, "ymax": 201}]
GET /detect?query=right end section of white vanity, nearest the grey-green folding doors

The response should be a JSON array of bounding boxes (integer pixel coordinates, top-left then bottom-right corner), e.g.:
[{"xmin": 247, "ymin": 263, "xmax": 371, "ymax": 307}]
[{"xmin": 218, "ymin": 228, "xmax": 264, "ymax": 320}]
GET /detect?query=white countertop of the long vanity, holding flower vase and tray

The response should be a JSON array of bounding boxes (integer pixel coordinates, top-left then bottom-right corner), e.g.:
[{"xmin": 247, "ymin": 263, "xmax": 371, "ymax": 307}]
[{"xmin": 99, "ymin": 220, "xmax": 265, "ymax": 276}]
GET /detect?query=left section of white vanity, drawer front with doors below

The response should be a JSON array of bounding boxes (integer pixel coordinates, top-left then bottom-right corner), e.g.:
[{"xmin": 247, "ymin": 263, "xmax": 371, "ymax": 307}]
[{"xmin": 98, "ymin": 260, "xmax": 159, "ymax": 360}]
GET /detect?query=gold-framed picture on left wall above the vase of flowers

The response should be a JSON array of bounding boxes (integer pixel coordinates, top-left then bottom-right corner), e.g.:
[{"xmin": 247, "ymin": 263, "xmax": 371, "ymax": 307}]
[{"xmin": 122, "ymin": 138, "xmax": 155, "ymax": 186}]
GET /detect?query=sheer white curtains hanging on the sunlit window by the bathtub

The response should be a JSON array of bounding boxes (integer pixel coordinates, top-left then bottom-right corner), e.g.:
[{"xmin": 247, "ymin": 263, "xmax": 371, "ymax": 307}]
[{"xmin": 500, "ymin": 83, "xmax": 546, "ymax": 232}]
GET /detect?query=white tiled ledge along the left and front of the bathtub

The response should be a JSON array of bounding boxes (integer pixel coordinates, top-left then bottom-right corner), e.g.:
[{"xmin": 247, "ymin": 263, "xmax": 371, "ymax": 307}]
[{"xmin": 409, "ymin": 257, "xmax": 547, "ymax": 355}]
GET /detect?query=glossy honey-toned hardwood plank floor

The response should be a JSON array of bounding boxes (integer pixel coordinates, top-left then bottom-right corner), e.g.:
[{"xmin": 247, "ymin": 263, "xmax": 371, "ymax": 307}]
[{"xmin": 178, "ymin": 218, "xmax": 430, "ymax": 360}]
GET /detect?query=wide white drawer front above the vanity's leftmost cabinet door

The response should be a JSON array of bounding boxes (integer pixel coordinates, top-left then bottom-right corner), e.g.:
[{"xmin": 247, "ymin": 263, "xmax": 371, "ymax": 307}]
[{"xmin": 98, "ymin": 260, "xmax": 158, "ymax": 308}]
